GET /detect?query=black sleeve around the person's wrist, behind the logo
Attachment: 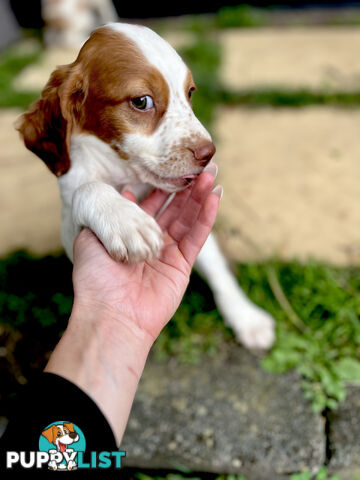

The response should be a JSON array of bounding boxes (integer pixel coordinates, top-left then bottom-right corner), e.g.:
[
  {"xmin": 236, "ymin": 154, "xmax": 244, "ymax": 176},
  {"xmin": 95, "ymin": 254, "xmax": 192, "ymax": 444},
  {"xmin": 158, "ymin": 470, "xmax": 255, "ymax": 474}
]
[{"xmin": 0, "ymin": 372, "xmax": 118, "ymax": 471}]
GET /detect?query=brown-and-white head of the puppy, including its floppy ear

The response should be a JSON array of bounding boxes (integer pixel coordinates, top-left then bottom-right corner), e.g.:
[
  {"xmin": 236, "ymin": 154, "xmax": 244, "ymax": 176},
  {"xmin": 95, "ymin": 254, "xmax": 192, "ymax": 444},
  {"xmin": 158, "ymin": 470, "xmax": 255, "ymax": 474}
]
[{"xmin": 19, "ymin": 23, "xmax": 215, "ymax": 191}]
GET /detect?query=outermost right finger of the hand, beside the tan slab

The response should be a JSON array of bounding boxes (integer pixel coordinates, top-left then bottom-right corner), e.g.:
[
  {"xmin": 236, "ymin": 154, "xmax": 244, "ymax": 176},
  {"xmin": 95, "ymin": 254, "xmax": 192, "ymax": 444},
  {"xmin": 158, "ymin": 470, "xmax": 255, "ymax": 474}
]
[{"xmin": 178, "ymin": 191, "xmax": 222, "ymax": 267}]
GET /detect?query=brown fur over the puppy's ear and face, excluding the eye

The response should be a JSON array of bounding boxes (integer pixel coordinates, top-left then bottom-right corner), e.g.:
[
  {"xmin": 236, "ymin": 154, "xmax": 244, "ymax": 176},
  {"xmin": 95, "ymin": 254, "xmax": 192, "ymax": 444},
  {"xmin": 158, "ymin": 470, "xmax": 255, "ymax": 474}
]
[{"xmin": 18, "ymin": 27, "xmax": 170, "ymax": 176}]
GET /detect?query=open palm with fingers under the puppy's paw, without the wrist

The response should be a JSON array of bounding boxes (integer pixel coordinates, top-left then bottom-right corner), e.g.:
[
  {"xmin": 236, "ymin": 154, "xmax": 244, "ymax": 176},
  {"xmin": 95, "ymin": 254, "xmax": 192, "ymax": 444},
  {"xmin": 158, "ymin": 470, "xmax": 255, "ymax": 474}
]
[{"xmin": 73, "ymin": 172, "xmax": 219, "ymax": 340}]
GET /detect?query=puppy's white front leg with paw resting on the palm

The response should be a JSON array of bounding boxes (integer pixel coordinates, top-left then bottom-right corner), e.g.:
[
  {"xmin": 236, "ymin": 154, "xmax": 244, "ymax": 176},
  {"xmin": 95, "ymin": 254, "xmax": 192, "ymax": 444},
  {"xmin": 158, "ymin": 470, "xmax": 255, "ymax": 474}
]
[{"xmin": 62, "ymin": 182, "xmax": 163, "ymax": 263}]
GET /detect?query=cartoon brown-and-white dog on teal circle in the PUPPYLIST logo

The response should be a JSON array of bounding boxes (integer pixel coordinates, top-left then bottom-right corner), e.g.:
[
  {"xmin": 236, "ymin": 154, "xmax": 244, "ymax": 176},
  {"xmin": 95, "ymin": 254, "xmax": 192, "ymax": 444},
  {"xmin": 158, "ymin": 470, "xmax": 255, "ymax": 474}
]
[{"xmin": 39, "ymin": 421, "xmax": 85, "ymax": 470}]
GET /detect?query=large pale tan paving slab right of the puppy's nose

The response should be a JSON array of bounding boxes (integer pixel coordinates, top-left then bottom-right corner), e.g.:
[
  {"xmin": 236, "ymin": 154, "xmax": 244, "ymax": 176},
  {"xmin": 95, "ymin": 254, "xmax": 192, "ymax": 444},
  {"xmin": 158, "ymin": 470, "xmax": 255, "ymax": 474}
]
[{"xmin": 214, "ymin": 107, "xmax": 360, "ymax": 265}]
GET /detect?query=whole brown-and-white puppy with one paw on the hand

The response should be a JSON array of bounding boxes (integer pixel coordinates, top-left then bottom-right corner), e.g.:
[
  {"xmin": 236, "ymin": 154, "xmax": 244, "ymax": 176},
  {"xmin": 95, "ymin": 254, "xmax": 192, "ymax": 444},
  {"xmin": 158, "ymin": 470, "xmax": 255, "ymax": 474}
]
[{"xmin": 18, "ymin": 23, "xmax": 274, "ymax": 348}]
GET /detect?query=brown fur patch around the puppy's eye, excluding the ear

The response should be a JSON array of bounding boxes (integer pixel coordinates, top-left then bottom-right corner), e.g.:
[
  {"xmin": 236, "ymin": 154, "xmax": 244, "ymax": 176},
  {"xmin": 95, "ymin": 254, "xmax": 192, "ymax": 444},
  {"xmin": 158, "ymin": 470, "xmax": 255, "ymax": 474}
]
[{"xmin": 77, "ymin": 27, "xmax": 169, "ymax": 143}]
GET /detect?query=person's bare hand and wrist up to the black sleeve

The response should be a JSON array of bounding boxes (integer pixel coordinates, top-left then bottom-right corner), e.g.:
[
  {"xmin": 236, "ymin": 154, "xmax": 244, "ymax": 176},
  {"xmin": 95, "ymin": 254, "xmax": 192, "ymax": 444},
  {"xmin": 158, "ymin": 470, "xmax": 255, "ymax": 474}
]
[{"xmin": 45, "ymin": 168, "xmax": 222, "ymax": 444}]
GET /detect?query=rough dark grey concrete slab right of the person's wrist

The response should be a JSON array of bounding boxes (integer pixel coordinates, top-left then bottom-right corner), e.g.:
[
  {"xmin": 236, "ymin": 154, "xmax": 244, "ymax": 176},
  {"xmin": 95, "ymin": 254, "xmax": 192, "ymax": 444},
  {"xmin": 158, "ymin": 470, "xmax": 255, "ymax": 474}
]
[{"xmin": 122, "ymin": 345, "xmax": 325, "ymax": 480}]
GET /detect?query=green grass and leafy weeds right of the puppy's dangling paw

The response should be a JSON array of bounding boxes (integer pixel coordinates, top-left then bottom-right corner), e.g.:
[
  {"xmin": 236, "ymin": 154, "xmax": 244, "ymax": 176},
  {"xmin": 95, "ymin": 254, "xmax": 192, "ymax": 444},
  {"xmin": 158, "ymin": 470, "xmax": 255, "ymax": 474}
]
[{"xmin": 238, "ymin": 261, "xmax": 360, "ymax": 412}]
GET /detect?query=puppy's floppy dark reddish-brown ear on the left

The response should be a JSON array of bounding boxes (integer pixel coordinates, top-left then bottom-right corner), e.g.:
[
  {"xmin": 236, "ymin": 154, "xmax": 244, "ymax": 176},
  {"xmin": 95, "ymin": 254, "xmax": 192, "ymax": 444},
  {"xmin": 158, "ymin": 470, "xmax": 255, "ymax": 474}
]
[{"xmin": 16, "ymin": 65, "xmax": 86, "ymax": 176}]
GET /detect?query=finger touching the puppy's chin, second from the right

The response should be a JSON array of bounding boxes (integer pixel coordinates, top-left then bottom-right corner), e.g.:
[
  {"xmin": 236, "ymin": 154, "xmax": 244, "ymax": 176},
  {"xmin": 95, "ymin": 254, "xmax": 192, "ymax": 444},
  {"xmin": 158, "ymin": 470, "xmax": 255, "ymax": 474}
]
[{"xmin": 167, "ymin": 172, "xmax": 214, "ymax": 241}]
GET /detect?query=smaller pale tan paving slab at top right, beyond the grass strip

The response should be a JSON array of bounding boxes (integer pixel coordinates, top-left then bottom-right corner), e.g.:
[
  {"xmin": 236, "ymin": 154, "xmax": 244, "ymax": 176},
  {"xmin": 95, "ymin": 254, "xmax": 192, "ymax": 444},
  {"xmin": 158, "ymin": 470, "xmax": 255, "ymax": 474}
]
[{"xmin": 219, "ymin": 26, "xmax": 360, "ymax": 91}]
